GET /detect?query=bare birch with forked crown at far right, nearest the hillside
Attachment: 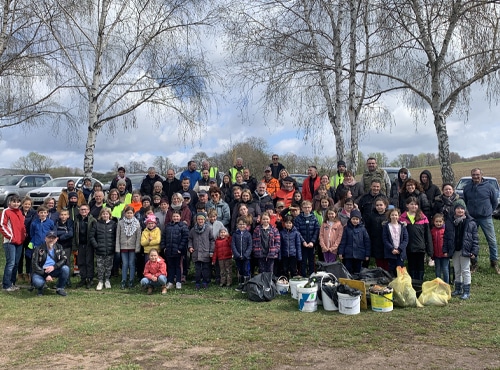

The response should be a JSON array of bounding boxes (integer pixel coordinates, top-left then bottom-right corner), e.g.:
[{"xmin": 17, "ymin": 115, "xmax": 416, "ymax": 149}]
[{"xmin": 371, "ymin": 0, "xmax": 500, "ymax": 182}]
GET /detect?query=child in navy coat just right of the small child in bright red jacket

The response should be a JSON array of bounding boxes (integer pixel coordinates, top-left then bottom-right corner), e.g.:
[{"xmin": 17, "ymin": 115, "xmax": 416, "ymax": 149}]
[{"xmin": 231, "ymin": 217, "xmax": 252, "ymax": 292}]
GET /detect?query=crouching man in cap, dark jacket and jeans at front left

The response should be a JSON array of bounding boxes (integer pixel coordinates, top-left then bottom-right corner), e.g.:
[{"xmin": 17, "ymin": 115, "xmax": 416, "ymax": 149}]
[{"xmin": 31, "ymin": 231, "xmax": 69, "ymax": 297}]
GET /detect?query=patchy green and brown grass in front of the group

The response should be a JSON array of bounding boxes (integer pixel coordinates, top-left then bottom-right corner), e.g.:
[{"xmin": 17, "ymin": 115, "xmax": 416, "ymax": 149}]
[{"xmin": 0, "ymin": 221, "xmax": 500, "ymax": 369}]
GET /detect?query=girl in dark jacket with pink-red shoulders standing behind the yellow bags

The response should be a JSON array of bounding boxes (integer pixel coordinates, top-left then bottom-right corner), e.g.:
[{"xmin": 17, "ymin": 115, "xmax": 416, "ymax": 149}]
[{"xmin": 399, "ymin": 197, "xmax": 434, "ymax": 281}]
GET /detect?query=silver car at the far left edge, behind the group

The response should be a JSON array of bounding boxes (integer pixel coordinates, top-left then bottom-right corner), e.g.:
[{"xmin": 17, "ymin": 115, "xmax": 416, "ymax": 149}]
[{"xmin": 0, "ymin": 173, "xmax": 52, "ymax": 208}]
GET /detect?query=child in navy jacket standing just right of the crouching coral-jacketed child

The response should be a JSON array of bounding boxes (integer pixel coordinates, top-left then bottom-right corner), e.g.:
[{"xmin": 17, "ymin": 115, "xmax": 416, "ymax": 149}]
[{"xmin": 161, "ymin": 210, "xmax": 189, "ymax": 290}]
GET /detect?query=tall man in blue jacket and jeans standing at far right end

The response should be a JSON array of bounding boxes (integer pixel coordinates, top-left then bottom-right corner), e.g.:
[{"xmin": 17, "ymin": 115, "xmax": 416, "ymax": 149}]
[{"xmin": 464, "ymin": 168, "xmax": 500, "ymax": 274}]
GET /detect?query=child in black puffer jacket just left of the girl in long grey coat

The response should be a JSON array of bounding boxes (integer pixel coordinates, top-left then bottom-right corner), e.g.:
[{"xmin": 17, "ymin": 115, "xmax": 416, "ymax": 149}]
[{"xmin": 90, "ymin": 208, "xmax": 116, "ymax": 291}]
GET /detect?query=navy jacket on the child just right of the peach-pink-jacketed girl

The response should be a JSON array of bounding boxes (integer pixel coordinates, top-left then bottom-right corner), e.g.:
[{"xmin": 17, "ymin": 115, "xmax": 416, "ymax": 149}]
[{"xmin": 339, "ymin": 220, "xmax": 371, "ymax": 260}]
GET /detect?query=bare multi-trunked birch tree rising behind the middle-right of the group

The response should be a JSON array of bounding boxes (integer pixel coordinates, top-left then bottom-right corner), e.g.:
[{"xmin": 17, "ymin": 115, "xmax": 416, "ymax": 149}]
[{"xmin": 222, "ymin": 0, "xmax": 385, "ymax": 168}]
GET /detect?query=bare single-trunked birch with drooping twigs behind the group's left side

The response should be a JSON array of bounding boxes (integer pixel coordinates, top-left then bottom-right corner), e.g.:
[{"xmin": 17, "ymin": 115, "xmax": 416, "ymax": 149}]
[{"xmin": 40, "ymin": 0, "xmax": 210, "ymax": 176}]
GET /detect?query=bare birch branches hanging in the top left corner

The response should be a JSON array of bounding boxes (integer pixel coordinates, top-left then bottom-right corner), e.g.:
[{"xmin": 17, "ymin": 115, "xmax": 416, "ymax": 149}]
[{"xmin": 0, "ymin": 0, "xmax": 65, "ymax": 128}]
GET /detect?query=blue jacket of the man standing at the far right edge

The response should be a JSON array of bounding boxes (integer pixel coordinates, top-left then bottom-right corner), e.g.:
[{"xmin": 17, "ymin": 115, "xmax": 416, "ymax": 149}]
[{"xmin": 464, "ymin": 179, "xmax": 498, "ymax": 218}]
